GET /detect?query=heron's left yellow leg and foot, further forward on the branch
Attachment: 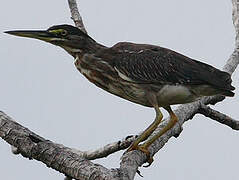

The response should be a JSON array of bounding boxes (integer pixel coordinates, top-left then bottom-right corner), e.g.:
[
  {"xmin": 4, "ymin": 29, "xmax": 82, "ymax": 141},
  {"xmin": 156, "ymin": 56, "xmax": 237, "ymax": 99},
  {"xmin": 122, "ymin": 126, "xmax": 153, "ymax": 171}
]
[{"xmin": 127, "ymin": 106, "xmax": 163, "ymax": 154}]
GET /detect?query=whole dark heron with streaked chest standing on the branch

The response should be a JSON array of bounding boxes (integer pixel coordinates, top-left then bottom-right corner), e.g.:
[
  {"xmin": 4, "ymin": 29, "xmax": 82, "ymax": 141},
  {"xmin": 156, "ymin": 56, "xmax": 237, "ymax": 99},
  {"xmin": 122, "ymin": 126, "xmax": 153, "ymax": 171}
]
[{"xmin": 5, "ymin": 24, "xmax": 235, "ymax": 165}]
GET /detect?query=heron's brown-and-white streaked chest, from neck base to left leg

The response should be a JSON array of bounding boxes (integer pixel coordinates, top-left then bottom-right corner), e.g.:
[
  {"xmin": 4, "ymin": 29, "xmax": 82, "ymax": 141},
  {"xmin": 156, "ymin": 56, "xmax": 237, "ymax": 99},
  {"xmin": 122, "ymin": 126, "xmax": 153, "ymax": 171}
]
[{"xmin": 75, "ymin": 55, "xmax": 151, "ymax": 107}]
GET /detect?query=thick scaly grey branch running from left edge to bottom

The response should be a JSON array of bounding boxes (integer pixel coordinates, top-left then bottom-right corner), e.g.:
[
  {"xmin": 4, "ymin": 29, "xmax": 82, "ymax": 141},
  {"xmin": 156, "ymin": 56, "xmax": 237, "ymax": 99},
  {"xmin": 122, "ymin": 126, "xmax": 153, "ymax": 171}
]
[{"xmin": 0, "ymin": 111, "xmax": 118, "ymax": 180}]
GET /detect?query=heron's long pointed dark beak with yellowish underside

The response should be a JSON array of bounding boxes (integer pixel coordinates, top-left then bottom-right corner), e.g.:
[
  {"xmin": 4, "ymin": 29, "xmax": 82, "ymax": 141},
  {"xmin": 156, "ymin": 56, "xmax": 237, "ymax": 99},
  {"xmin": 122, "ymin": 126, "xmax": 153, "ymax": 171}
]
[{"xmin": 4, "ymin": 30, "xmax": 57, "ymax": 42}]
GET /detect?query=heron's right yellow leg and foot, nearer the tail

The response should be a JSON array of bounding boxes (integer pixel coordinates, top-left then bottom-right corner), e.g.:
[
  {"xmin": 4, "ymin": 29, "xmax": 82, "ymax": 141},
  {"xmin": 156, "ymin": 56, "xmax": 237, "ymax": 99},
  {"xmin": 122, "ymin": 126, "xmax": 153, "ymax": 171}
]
[{"xmin": 138, "ymin": 106, "xmax": 178, "ymax": 167}]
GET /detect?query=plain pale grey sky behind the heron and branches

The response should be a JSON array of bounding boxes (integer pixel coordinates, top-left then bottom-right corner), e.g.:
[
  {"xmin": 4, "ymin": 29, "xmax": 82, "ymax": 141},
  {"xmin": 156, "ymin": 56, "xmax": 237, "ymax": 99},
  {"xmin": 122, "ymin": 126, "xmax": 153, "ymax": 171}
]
[{"xmin": 0, "ymin": 0, "xmax": 239, "ymax": 180}]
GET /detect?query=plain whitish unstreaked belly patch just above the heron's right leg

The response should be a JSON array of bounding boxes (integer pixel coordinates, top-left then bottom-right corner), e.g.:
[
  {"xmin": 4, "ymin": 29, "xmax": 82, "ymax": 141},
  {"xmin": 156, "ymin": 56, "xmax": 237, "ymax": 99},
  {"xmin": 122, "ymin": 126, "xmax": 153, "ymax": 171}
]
[{"xmin": 157, "ymin": 85, "xmax": 199, "ymax": 107}]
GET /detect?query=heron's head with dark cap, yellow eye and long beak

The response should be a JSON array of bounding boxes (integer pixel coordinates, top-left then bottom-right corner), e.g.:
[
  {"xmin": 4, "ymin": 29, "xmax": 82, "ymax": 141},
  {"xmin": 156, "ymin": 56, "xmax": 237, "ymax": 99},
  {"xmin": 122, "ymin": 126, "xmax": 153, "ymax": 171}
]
[{"xmin": 5, "ymin": 24, "xmax": 96, "ymax": 54}]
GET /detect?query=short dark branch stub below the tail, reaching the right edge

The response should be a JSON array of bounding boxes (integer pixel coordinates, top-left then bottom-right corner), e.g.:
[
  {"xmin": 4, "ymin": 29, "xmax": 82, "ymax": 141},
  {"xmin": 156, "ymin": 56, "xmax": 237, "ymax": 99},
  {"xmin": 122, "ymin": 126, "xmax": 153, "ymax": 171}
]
[{"xmin": 198, "ymin": 104, "xmax": 239, "ymax": 130}]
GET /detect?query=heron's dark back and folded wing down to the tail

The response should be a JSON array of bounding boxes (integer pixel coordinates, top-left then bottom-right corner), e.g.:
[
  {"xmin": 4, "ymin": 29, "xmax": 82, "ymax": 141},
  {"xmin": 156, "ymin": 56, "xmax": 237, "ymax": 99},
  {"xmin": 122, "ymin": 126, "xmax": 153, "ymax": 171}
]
[{"xmin": 98, "ymin": 42, "xmax": 235, "ymax": 96}]
